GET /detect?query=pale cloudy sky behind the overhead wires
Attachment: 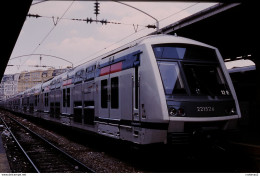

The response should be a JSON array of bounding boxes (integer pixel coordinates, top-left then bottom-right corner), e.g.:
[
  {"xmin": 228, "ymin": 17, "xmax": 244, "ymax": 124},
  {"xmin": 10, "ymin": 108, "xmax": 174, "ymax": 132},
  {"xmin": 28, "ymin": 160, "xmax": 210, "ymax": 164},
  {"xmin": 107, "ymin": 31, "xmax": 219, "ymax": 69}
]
[{"xmin": 5, "ymin": 1, "xmax": 218, "ymax": 74}]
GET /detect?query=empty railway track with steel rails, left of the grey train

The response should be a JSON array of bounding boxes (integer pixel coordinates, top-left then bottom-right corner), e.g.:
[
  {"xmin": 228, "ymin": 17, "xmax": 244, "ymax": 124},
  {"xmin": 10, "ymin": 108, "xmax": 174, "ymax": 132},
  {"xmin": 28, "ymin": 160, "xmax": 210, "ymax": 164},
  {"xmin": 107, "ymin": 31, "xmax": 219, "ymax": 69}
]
[{"xmin": 0, "ymin": 116, "xmax": 94, "ymax": 173}]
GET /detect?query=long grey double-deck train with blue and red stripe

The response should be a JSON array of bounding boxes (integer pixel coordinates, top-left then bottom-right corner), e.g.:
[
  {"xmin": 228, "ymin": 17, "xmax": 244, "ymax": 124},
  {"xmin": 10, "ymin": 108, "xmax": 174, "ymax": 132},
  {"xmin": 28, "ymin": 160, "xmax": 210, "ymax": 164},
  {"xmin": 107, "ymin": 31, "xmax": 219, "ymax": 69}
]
[{"xmin": 1, "ymin": 34, "xmax": 241, "ymax": 145}]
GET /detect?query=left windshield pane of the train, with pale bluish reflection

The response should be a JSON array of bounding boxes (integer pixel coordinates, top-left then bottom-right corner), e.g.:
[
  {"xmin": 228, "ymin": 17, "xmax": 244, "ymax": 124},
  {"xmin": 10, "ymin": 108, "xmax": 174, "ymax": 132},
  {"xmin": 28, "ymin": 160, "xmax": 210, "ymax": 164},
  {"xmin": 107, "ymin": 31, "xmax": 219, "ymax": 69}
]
[{"xmin": 158, "ymin": 62, "xmax": 186, "ymax": 95}]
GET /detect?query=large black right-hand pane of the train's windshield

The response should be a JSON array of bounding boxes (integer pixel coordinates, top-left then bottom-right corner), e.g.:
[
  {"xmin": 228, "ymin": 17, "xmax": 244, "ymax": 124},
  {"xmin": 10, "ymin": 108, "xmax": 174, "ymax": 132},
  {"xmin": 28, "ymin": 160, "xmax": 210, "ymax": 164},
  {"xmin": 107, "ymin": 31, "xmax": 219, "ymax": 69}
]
[{"xmin": 183, "ymin": 64, "xmax": 230, "ymax": 96}]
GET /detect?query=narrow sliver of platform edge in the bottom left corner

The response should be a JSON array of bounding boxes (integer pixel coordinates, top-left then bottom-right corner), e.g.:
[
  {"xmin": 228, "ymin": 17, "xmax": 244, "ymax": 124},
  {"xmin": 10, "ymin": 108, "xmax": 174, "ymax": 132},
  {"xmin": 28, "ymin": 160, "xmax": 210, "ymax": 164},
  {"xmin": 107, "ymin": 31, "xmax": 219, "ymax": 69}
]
[{"xmin": 0, "ymin": 126, "xmax": 12, "ymax": 173}]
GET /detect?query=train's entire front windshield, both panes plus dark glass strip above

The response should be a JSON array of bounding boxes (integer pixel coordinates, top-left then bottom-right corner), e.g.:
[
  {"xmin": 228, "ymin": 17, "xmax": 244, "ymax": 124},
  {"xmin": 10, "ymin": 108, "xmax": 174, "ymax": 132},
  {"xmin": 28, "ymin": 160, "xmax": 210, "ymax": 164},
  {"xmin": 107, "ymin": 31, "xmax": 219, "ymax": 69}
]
[{"xmin": 153, "ymin": 44, "xmax": 230, "ymax": 96}]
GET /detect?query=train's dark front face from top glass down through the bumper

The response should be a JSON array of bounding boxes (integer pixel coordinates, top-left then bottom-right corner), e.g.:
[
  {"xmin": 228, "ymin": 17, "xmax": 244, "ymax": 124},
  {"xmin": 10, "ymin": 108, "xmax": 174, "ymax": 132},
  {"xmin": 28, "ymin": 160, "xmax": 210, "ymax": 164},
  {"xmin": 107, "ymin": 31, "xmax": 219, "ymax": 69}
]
[{"xmin": 153, "ymin": 44, "xmax": 240, "ymax": 144}]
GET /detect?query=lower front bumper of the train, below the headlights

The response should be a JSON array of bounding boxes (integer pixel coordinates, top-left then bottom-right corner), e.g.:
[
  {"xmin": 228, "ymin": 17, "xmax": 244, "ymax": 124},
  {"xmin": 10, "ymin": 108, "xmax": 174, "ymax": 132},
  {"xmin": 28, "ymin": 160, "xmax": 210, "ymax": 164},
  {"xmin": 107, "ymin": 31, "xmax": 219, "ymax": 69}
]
[{"xmin": 167, "ymin": 115, "xmax": 239, "ymax": 144}]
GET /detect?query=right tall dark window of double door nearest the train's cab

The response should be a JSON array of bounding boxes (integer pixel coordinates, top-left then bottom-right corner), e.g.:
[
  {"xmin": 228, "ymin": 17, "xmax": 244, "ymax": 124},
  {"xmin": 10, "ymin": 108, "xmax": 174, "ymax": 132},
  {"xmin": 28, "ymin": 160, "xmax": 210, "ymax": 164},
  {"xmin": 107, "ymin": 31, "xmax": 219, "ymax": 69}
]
[{"xmin": 111, "ymin": 77, "xmax": 119, "ymax": 109}]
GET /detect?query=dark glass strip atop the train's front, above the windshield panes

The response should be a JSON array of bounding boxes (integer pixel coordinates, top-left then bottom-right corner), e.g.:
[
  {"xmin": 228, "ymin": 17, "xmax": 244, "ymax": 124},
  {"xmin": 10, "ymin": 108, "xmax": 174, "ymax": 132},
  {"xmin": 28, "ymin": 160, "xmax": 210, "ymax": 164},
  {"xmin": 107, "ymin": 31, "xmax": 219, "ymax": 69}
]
[{"xmin": 153, "ymin": 44, "xmax": 217, "ymax": 61}]
